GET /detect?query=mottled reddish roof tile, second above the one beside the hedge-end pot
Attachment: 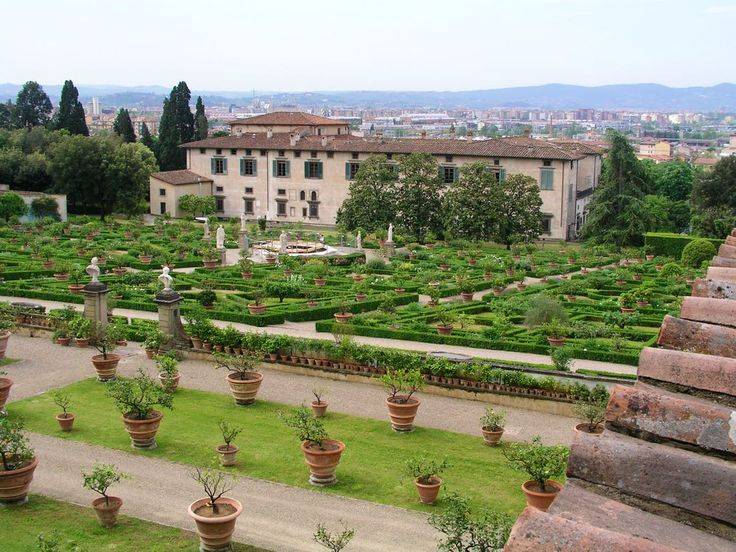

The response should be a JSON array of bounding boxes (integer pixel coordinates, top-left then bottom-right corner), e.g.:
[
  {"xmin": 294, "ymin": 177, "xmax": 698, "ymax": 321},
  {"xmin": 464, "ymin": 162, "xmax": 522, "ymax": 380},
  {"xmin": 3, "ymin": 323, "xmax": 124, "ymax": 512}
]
[{"xmin": 657, "ymin": 315, "xmax": 736, "ymax": 358}]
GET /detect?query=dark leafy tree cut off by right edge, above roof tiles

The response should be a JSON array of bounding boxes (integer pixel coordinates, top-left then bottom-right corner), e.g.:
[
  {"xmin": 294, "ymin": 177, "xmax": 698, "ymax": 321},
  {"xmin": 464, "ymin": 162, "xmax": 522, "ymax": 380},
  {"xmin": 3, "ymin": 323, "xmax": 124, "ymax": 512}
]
[{"xmin": 691, "ymin": 155, "xmax": 736, "ymax": 238}]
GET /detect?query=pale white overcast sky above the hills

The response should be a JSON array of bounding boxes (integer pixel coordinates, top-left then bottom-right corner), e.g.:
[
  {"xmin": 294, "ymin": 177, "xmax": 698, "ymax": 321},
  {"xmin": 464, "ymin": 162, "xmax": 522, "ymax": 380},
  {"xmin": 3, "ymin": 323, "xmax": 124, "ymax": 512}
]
[{"xmin": 0, "ymin": 0, "xmax": 736, "ymax": 91}]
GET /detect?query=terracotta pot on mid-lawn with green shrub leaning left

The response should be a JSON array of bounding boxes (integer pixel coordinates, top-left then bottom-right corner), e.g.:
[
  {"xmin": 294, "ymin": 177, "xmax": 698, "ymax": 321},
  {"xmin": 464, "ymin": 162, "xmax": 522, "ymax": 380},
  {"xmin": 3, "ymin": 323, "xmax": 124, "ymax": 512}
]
[{"xmin": 280, "ymin": 406, "xmax": 345, "ymax": 486}]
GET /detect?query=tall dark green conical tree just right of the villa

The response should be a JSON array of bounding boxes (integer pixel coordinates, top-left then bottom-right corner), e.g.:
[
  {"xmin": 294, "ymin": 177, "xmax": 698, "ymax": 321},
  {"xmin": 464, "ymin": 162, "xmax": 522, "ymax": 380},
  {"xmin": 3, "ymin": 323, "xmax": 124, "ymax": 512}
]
[{"xmin": 582, "ymin": 132, "xmax": 649, "ymax": 248}]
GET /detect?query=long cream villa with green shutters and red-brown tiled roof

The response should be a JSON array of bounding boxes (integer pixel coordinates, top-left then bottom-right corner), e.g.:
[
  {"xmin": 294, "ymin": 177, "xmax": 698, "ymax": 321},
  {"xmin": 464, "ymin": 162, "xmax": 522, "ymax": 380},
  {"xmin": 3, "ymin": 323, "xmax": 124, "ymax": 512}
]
[{"xmin": 150, "ymin": 112, "xmax": 603, "ymax": 239}]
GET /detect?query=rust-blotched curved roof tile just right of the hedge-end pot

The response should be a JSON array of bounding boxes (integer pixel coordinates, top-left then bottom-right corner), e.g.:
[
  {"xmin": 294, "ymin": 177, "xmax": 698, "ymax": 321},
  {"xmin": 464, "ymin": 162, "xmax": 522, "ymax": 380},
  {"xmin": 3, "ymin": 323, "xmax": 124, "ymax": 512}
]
[{"xmin": 606, "ymin": 383, "xmax": 736, "ymax": 454}]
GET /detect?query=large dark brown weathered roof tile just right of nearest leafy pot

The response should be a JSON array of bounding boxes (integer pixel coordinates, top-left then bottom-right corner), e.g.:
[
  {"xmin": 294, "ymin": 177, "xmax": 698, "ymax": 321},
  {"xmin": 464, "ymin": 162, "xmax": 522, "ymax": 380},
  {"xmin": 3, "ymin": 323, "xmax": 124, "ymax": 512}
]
[{"xmin": 567, "ymin": 431, "xmax": 736, "ymax": 526}]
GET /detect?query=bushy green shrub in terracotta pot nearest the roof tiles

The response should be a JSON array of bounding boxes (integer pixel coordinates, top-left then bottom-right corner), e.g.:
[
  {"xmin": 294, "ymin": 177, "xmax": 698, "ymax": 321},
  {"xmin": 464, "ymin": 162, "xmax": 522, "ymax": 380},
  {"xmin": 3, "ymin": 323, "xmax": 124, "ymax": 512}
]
[{"xmin": 503, "ymin": 435, "xmax": 569, "ymax": 511}]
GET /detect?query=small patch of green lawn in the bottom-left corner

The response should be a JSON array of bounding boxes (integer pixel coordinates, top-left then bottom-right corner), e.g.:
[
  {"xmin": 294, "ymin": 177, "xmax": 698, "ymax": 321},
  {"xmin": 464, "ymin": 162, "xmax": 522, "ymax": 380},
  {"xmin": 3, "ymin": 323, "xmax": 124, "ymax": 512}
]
[{"xmin": 0, "ymin": 495, "xmax": 265, "ymax": 552}]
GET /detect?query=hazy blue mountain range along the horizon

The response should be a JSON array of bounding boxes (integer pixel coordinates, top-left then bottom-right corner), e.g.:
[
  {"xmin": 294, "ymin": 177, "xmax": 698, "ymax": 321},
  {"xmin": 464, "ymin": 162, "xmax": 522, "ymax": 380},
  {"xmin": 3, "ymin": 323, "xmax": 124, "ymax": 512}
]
[{"xmin": 0, "ymin": 83, "xmax": 736, "ymax": 112}]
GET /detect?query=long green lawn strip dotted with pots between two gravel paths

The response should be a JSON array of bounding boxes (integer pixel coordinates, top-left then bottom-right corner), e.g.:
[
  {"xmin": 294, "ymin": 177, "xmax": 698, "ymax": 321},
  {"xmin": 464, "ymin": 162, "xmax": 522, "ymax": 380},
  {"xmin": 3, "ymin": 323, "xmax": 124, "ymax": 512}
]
[{"xmin": 9, "ymin": 379, "xmax": 526, "ymax": 514}]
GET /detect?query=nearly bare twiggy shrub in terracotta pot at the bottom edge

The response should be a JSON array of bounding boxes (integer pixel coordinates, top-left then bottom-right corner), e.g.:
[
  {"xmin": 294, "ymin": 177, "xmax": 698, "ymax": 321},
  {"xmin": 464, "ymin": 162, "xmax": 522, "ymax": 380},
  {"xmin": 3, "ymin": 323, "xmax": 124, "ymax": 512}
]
[{"xmin": 188, "ymin": 468, "xmax": 243, "ymax": 550}]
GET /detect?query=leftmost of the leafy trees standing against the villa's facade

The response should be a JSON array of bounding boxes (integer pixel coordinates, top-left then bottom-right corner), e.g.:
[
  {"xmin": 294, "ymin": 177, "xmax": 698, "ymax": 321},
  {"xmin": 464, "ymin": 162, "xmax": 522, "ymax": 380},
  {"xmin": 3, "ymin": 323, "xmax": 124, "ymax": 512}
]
[{"xmin": 337, "ymin": 155, "xmax": 396, "ymax": 232}]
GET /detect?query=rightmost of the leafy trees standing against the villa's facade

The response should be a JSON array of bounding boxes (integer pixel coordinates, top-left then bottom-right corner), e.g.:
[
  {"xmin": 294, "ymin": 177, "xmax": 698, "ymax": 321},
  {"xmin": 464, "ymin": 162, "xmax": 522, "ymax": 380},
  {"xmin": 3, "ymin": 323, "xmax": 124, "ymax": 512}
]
[{"xmin": 494, "ymin": 174, "xmax": 542, "ymax": 248}]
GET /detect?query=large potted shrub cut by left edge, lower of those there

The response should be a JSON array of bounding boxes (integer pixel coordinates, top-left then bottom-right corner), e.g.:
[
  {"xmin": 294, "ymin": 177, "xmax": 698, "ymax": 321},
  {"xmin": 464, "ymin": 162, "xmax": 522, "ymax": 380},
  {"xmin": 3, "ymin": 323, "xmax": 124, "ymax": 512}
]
[{"xmin": 0, "ymin": 416, "xmax": 38, "ymax": 504}]
